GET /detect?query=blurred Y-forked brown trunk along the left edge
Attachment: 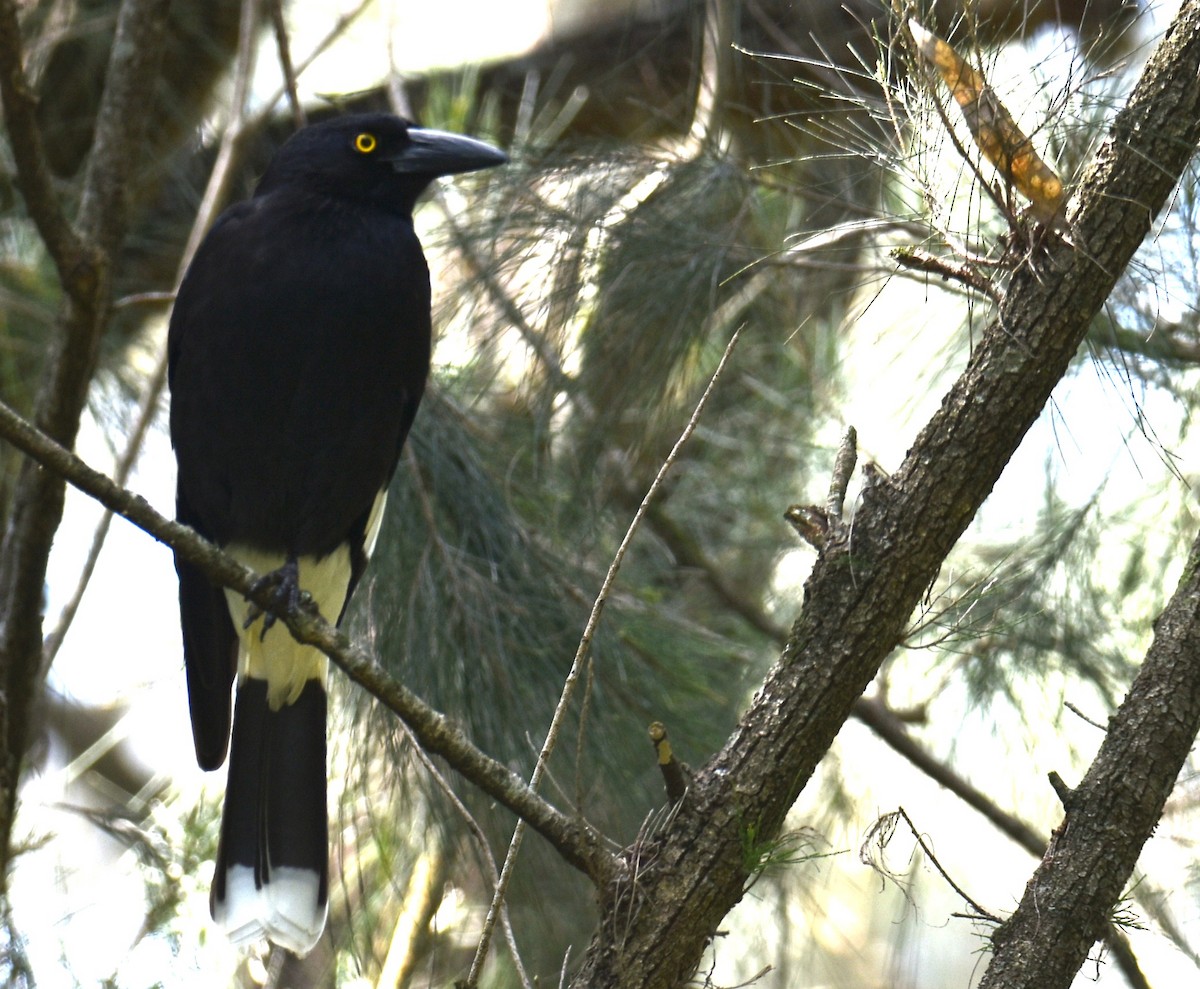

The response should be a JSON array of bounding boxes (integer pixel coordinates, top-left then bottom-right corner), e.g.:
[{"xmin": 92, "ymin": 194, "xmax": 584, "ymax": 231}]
[{"xmin": 0, "ymin": 0, "xmax": 169, "ymax": 873}]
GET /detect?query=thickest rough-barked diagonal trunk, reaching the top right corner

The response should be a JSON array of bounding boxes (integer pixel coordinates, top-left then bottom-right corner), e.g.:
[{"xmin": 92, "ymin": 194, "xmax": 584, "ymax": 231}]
[{"xmin": 574, "ymin": 0, "xmax": 1200, "ymax": 987}]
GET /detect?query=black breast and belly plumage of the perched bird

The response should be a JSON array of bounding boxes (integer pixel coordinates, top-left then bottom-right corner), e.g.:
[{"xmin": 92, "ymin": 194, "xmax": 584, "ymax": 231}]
[{"xmin": 169, "ymin": 188, "xmax": 430, "ymax": 556}]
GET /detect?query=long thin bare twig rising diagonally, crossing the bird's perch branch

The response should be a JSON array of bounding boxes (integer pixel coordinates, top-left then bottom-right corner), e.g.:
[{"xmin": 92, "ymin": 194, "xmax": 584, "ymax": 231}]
[{"xmin": 467, "ymin": 328, "xmax": 742, "ymax": 987}]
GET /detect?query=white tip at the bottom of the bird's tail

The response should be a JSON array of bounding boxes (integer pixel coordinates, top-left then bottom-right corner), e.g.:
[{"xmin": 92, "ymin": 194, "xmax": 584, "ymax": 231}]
[{"xmin": 212, "ymin": 865, "xmax": 329, "ymax": 957}]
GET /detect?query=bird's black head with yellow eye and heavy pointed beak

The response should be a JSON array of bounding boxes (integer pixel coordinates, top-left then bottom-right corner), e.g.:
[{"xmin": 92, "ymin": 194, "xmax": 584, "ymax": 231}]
[{"xmin": 257, "ymin": 113, "xmax": 508, "ymax": 212}]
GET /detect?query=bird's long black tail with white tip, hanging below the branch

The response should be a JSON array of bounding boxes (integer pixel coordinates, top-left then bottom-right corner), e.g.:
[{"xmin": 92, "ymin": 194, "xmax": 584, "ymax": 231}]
[{"xmin": 211, "ymin": 676, "xmax": 329, "ymax": 955}]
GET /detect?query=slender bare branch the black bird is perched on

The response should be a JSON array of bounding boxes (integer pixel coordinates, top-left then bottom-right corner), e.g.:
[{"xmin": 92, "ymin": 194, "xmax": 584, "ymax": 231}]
[{"xmin": 0, "ymin": 402, "xmax": 617, "ymax": 885}]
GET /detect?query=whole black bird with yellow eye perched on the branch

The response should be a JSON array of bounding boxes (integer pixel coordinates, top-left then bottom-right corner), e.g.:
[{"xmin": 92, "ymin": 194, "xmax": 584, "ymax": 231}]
[{"xmin": 168, "ymin": 114, "xmax": 505, "ymax": 954}]
